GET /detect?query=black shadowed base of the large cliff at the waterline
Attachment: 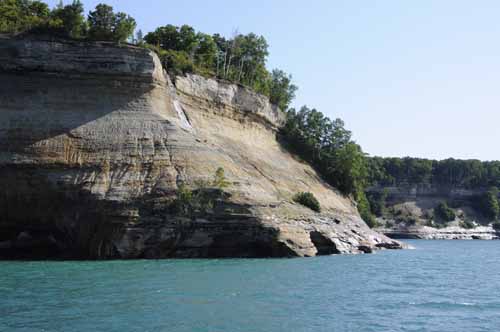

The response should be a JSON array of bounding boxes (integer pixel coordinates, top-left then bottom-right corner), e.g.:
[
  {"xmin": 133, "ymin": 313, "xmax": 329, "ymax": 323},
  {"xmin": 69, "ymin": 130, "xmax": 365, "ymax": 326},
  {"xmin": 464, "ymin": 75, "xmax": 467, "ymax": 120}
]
[{"xmin": 0, "ymin": 167, "xmax": 131, "ymax": 259}]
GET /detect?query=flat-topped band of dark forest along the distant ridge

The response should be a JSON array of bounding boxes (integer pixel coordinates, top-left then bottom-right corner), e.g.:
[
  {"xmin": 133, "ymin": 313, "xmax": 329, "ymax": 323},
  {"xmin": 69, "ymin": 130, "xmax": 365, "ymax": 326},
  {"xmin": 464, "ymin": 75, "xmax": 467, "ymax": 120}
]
[{"xmin": 367, "ymin": 157, "xmax": 500, "ymax": 189}]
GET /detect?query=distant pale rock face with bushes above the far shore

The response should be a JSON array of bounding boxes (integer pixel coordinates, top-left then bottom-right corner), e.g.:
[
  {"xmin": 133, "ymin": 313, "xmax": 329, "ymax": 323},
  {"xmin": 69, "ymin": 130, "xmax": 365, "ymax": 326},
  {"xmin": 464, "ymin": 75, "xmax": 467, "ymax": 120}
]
[{"xmin": 367, "ymin": 185, "xmax": 499, "ymax": 240}]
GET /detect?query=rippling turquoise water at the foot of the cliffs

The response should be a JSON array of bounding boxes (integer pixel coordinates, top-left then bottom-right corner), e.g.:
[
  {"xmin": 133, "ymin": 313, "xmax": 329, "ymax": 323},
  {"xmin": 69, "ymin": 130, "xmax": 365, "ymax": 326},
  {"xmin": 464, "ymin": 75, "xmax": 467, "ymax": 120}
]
[{"xmin": 0, "ymin": 241, "xmax": 500, "ymax": 332}]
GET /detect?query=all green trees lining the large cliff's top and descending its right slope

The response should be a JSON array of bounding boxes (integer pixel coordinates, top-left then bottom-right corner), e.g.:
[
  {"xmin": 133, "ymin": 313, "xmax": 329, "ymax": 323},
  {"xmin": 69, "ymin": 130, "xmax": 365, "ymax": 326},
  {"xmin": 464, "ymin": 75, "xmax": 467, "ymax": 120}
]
[{"xmin": 0, "ymin": 0, "xmax": 373, "ymax": 226}]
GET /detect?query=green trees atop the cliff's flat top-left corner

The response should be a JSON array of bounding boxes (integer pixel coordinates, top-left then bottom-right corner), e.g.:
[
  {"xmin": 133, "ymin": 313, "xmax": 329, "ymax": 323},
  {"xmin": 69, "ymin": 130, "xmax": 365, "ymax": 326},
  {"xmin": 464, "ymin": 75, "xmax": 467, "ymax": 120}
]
[{"xmin": 0, "ymin": 0, "xmax": 136, "ymax": 42}]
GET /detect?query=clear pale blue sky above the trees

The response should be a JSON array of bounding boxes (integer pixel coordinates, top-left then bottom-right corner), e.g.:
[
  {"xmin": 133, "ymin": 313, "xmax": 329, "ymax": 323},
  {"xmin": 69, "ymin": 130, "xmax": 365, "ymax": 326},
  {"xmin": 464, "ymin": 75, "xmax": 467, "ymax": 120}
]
[{"xmin": 48, "ymin": 0, "xmax": 500, "ymax": 160}]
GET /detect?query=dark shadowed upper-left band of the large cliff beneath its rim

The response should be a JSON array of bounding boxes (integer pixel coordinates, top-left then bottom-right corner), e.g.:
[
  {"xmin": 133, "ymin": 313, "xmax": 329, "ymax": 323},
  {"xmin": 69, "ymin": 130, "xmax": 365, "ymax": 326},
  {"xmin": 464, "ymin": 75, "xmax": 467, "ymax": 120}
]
[{"xmin": 0, "ymin": 73, "xmax": 159, "ymax": 153}]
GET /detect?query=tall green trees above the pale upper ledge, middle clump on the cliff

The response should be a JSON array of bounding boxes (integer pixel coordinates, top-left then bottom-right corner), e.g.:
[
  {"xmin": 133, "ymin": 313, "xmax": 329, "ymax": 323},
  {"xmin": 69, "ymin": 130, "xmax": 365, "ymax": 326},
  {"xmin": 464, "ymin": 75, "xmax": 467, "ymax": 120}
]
[{"xmin": 144, "ymin": 24, "xmax": 297, "ymax": 110}]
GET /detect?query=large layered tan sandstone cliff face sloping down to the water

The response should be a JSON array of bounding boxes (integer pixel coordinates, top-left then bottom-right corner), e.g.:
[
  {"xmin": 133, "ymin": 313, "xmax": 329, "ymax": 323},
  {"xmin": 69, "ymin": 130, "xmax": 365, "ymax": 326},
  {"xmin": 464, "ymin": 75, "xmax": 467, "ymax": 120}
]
[{"xmin": 0, "ymin": 37, "xmax": 402, "ymax": 258}]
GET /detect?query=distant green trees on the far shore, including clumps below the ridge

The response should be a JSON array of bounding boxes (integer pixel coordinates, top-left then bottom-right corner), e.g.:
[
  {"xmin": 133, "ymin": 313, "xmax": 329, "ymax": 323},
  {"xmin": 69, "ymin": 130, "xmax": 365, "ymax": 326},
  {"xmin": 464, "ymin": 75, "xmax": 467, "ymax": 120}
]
[{"xmin": 366, "ymin": 157, "xmax": 500, "ymax": 222}]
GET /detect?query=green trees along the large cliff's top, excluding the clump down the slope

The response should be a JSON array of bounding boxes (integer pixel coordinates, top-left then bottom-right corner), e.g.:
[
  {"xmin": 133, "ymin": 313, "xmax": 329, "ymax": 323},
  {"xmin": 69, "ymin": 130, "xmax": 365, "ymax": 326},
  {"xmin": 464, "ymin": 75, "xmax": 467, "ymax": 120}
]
[{"xmin": 0, "ymin": 0, "xmax": 297, "ymax": 110}]
